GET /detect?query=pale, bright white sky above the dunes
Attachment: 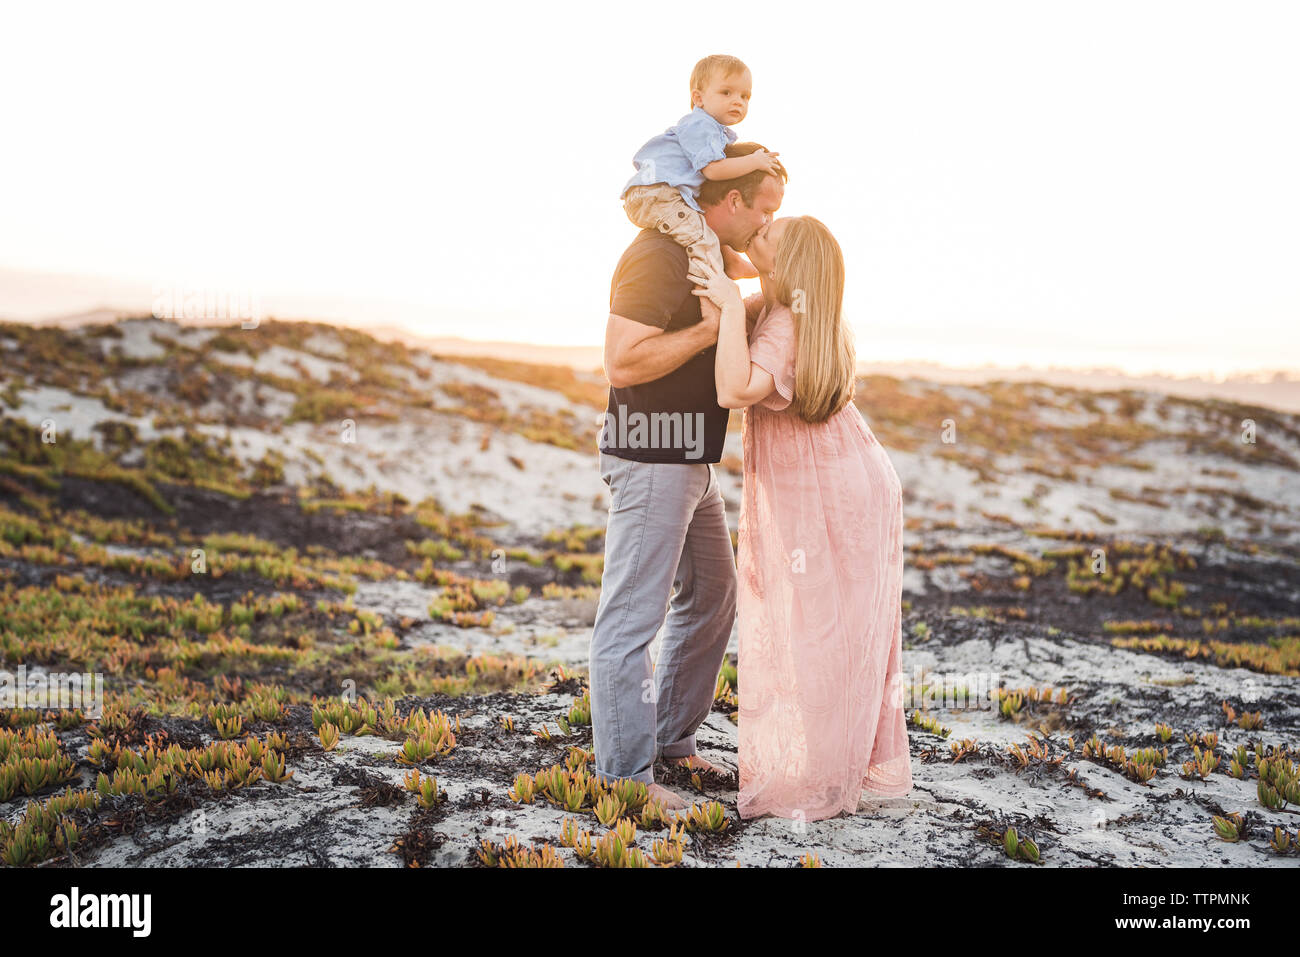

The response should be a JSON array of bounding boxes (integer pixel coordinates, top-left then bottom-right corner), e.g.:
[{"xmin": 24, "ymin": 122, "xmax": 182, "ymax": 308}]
[{"xmin": 0, "ymin": 0, "xmax": 1300, "ymax": 374}]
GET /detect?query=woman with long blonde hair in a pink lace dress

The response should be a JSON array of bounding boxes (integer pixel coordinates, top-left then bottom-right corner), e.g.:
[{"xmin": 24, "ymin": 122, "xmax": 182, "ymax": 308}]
[{"xmin": 693, "ymin": 216, "xmax": 911, "ymax": 820}]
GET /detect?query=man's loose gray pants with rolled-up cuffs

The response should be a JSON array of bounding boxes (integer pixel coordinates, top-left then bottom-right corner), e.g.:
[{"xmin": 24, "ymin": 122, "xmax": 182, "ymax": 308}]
[{"xmin": 590, "ymin": 451, "xmax": 737, "ymax": 784}]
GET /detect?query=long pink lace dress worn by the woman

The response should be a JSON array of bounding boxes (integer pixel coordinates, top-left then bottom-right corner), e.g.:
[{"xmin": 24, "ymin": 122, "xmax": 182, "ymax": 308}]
[{"xmin": 737, "ymin": 304, "xmax": 911, "ymax": 820}]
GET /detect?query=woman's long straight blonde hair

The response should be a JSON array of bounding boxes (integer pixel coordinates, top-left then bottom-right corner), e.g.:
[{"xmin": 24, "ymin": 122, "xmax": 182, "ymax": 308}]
[{"xmin": 774, "ymin": 216, "xmax": 857, "ymax": 423}]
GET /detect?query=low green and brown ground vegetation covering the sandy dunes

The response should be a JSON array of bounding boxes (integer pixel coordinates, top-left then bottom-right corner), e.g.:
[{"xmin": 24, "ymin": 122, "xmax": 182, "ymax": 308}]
[{"xmin": 0, "ymin": 322, "xmax": 1300, "ymax": 866}]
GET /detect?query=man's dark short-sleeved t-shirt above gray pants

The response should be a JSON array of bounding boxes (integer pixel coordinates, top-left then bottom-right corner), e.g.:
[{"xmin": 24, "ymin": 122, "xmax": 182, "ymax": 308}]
[{"xmin": 598, "ymin": 229, "xmax": 731, "ymax": 464}]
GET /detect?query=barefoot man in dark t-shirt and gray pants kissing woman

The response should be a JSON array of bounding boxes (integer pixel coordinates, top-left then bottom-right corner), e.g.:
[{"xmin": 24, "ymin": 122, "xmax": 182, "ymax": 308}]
[{"xmin": 590, "ymin": 143, "xmax": 787, "ymax": 809}]
